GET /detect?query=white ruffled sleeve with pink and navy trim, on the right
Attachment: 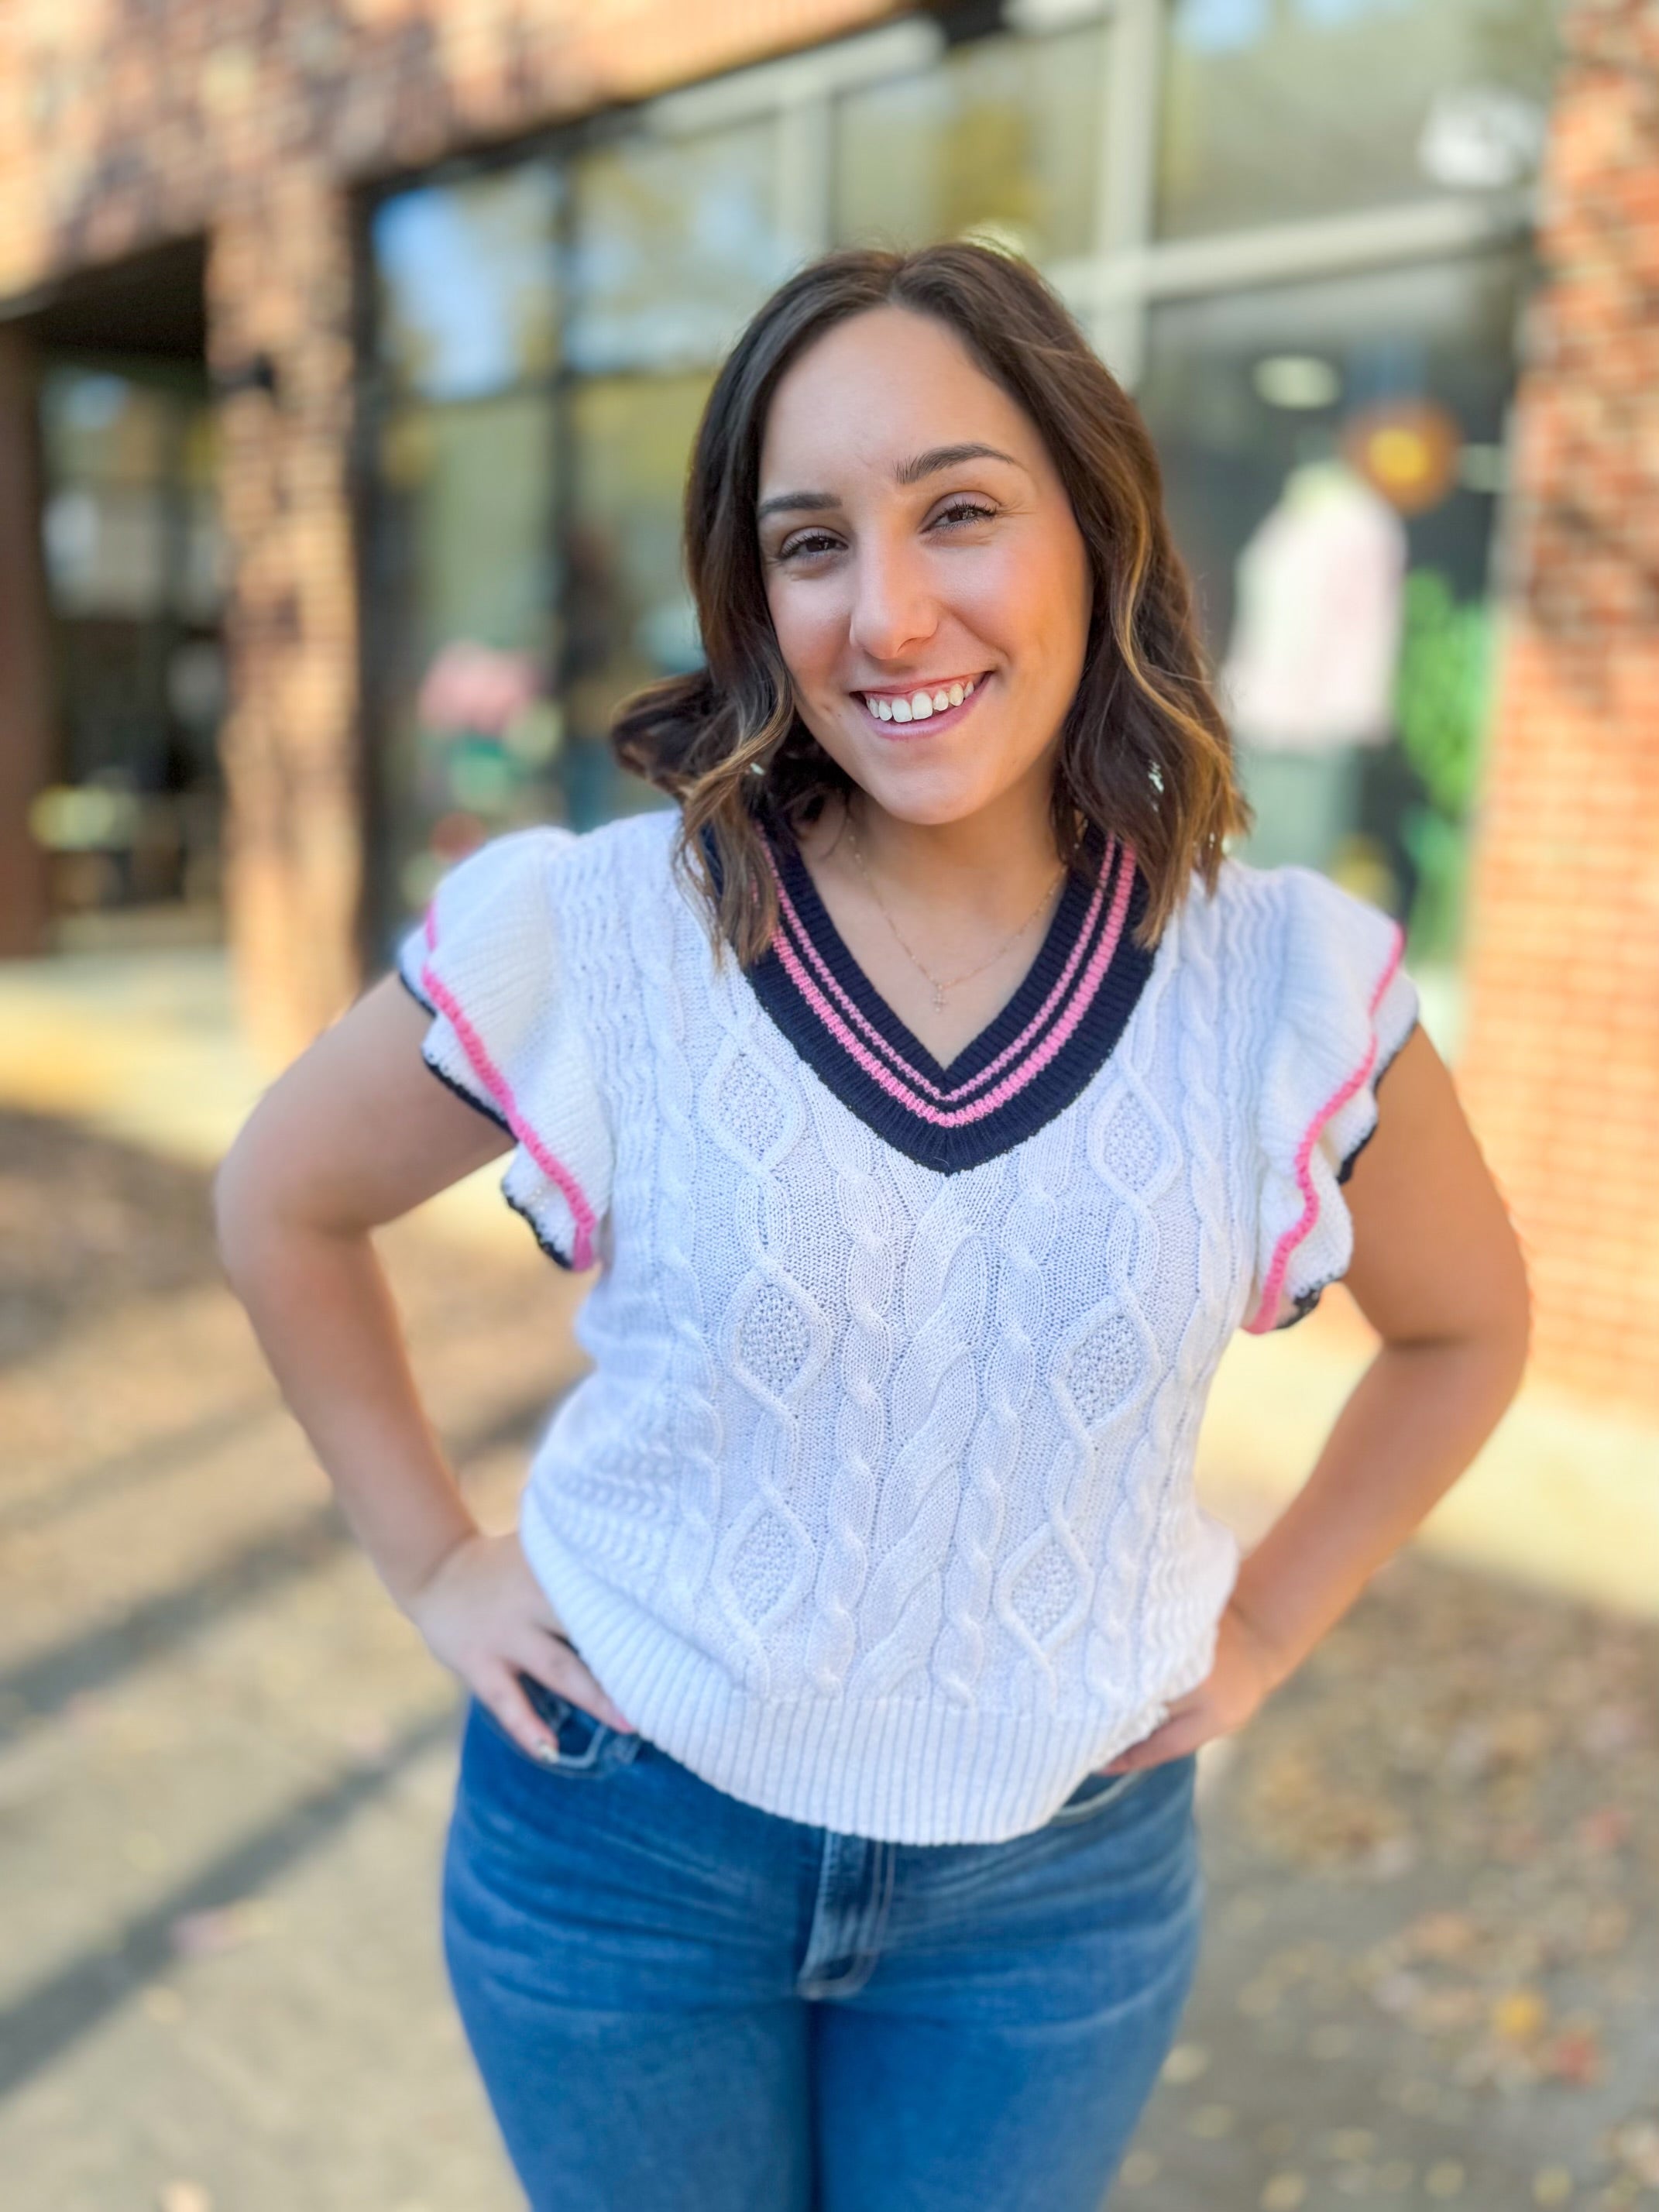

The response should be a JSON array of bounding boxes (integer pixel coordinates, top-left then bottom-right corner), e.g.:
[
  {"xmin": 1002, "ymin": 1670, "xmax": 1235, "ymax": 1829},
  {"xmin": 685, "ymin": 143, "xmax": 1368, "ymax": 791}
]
[{"xmin": 1245, "ymin": 867, "xmax": 1418, "ymax": 1336}]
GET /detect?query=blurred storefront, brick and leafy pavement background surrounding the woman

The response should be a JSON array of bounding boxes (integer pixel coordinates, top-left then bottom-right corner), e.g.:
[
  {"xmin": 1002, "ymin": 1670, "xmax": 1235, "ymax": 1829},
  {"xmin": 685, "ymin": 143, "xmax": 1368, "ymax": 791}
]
[{"xmin": 0, "ymin": 0, "xmax": 1659, "ymax": 2212}]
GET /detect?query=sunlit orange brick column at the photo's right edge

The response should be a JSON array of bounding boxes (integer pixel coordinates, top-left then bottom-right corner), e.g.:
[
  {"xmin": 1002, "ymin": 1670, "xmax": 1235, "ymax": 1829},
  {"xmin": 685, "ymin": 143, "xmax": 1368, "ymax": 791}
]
[{"xmin": 1460, "ymin": 0, "xmax": 1659, "ymax": 1409}]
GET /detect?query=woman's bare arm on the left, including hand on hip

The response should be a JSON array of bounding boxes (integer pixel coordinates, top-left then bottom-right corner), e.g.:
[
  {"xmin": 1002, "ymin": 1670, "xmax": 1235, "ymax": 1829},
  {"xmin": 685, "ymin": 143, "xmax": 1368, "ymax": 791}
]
[{"xmin": 212, "ymin": 975, "xmax": 626, "ymax": 1750}]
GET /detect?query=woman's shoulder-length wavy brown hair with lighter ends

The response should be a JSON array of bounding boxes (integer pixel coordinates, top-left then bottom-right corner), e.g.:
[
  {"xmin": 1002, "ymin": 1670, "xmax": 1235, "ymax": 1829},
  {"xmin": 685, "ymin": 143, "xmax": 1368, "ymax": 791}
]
[{"xmin": 610, "ymin": 243, "xmax": 1250, "ymax": 964}]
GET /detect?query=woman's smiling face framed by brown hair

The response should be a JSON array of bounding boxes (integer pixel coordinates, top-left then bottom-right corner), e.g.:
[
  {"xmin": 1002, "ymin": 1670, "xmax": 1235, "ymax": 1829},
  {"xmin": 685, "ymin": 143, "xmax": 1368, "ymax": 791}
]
[{"xmin": 759, "ymin": 307, "xmax": 1091, "ymax": 825}]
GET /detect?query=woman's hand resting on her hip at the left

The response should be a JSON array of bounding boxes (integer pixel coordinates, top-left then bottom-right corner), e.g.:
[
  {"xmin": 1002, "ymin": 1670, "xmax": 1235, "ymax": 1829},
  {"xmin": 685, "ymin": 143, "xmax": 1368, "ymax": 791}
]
[{"xmin": 405, "ymin": 1530, "xmax": 633, "ymax": 1760}]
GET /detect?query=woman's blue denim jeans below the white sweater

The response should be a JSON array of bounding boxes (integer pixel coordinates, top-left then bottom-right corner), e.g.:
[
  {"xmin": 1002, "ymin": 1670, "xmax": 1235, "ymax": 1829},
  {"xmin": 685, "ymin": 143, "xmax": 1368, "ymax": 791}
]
[{"xmin": 445, "ymin": 1681, "xmax": 1201, "ymax": 2212}]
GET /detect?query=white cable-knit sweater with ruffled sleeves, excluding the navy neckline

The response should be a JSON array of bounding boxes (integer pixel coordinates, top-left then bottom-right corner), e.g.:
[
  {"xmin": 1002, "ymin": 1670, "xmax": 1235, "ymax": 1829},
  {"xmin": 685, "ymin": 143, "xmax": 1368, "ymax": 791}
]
[{"xmin": 398, "ymin": 814, "xmax": 1416, "ymax": 1843}]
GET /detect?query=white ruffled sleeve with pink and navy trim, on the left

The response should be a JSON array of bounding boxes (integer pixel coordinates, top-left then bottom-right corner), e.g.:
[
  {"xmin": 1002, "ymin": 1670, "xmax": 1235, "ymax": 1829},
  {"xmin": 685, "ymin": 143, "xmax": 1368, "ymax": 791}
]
[{"xmin": 398, "ymin": 827, "xmax": 613, "ymax": 1269}]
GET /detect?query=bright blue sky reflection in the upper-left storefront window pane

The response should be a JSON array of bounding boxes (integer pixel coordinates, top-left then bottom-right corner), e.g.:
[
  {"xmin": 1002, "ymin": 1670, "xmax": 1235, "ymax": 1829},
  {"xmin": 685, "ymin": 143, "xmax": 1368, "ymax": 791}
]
[{"xmin": 374, "ymin": 163, "xmax": 558, "ymax": 400}]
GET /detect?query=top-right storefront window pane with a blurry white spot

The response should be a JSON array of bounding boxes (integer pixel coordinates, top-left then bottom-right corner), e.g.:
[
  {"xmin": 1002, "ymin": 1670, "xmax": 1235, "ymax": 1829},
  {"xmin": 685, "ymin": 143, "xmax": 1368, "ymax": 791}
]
[{"xmin": 1159, "ymin": 0, "xmax": 1555, "ymax": 239}]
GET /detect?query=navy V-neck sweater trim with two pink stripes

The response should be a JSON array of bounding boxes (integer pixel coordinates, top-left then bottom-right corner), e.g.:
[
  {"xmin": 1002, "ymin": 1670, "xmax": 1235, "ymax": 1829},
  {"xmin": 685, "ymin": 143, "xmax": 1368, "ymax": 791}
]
[{"xmin": 747, "ymin": 840, "xmax": 1152, "ymax": 1175}]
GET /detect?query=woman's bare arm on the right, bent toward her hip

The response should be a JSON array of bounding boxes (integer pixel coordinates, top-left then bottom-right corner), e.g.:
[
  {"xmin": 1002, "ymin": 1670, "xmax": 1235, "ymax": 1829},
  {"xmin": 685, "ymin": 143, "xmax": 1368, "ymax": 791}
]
[{"xmin": 1113, "ymin": 1029, "xmax": 1528, "ymax": 1772}]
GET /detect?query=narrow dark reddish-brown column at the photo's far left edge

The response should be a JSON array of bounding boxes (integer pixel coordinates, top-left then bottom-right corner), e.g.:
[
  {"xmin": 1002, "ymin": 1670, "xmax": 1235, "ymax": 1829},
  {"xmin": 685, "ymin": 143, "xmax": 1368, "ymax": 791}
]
[{"xmin": 0, "ymin": 330, "xmax": 53, "ymax": 958}]
